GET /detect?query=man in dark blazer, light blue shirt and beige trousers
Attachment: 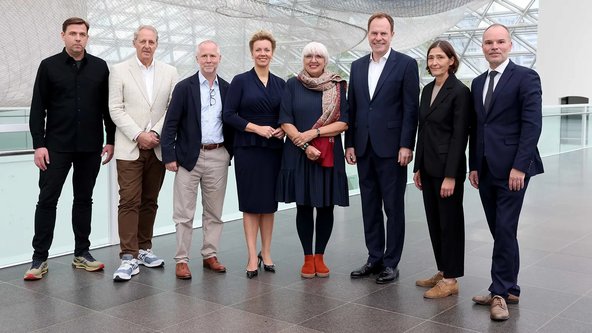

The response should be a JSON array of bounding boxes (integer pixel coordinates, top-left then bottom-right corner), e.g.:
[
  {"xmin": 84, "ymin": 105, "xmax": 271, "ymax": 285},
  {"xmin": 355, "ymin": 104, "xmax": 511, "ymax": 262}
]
[{"xmin": 161, "ymin": 40, "xmax": 233, "ymax": 279}]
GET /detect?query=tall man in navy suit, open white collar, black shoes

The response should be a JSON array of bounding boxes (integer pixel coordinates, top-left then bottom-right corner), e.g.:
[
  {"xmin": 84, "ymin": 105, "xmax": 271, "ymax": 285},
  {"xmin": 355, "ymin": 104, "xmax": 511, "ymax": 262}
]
[{"xmin": 345, "ymin": 13, "xmax": 419, "ymax": 284}]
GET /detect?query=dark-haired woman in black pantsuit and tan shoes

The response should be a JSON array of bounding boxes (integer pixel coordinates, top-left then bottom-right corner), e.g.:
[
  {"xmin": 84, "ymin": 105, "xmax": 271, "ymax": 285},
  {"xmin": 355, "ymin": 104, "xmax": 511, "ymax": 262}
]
[{"xmin": 413, "ymin": 41, "xmax": 472, "ymax": 298}]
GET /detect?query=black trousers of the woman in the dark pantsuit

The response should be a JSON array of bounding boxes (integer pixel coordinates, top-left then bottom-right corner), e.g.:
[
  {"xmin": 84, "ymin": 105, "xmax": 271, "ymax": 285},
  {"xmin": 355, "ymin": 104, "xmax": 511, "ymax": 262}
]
[{"xmin": 420, "ymin": 170, "xmax": 465, "ymax": 278}]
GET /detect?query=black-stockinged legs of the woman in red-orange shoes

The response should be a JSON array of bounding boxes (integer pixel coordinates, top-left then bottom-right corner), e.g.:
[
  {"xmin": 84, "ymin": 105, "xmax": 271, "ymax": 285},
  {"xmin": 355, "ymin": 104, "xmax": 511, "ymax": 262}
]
[{"xmin": 296, "ymin": 205, "xmax": 333, "ymax": 255}]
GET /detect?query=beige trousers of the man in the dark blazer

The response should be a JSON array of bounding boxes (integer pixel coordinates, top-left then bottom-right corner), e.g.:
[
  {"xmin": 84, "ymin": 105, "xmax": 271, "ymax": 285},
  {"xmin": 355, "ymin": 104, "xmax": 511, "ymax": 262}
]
[{"xmin": 173, "ymin": 147, "xmax": 230, "ymax": 263}]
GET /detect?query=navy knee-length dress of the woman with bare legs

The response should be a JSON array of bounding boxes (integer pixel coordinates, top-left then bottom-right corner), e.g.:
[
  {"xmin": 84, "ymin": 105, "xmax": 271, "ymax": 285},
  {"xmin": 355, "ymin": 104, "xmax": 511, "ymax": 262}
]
[{"xmin": 222, "ymin": 69, "xmax": 286, "ymax": 214}]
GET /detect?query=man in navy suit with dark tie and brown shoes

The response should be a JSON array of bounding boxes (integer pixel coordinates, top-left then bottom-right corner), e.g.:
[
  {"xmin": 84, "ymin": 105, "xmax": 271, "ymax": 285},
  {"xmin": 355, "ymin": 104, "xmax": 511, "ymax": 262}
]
[{"xmin": 469, "ymin": 24, "xmax": 543, "ymax": 320}]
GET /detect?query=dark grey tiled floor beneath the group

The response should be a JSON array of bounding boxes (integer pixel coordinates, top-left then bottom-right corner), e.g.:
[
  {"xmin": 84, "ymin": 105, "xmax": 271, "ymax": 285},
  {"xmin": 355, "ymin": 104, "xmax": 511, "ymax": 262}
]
[{"xmin": 0, "ymin": 150, "xmax": 592, "ymax": 333}]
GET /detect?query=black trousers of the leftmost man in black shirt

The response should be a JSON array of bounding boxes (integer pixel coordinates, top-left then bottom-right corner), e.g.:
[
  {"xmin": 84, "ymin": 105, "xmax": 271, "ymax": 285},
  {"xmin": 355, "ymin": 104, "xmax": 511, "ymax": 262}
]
[{"xmin": 33, "ymin": 151, "xmax": 101, "ymax": 261}]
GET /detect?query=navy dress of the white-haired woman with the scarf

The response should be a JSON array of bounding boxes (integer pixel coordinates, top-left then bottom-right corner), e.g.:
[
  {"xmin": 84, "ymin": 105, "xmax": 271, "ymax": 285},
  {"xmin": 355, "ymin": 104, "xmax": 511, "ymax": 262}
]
[{"xmin": 276, "ymin": 77, "xmax": 349, "ymax": 207}]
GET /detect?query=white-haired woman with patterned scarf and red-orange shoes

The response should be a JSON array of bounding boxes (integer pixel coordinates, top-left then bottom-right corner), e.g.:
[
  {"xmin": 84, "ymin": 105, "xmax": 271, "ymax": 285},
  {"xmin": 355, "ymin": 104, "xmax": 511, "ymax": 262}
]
[{"xmin": 276, "ymin": 42, "xmax": 349, "ymax": 278}]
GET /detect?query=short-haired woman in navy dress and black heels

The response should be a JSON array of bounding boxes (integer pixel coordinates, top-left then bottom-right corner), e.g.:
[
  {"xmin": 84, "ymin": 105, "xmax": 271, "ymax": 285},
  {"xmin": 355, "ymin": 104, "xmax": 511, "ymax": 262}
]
[{"xmin": 222, "ymin": 31, "xmax": 285, "ymax": 278}]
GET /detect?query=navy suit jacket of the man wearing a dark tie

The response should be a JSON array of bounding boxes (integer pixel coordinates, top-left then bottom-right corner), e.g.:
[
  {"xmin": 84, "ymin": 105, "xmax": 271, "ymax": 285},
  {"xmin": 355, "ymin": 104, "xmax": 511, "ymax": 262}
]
[{"xmin": 469, "ymin": 61, "xmax": 544, "ymax": 179}]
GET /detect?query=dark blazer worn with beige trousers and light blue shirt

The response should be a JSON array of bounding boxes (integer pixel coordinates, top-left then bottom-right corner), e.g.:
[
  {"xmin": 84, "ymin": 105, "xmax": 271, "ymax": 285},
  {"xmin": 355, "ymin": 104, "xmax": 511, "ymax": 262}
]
[{"xmin": 160, "ymin": 72, "xmax": 234, "ymax": 170}]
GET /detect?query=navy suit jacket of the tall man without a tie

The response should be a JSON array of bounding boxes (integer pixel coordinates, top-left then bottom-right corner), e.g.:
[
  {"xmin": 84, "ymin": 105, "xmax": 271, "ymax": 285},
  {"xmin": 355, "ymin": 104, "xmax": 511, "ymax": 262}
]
[{"xmin": 345, "ymin": 49, "xmax": 419, "ymax": 158}]
